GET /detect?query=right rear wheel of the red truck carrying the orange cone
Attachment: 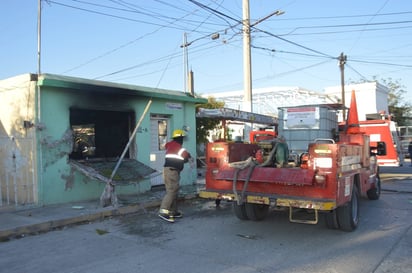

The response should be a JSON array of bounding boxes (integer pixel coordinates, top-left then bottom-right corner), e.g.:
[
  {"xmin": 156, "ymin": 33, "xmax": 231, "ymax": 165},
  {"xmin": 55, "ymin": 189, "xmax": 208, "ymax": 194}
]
[{"xmin": 336, "ymin": 184, "xmax": 359, "ymax": 231}]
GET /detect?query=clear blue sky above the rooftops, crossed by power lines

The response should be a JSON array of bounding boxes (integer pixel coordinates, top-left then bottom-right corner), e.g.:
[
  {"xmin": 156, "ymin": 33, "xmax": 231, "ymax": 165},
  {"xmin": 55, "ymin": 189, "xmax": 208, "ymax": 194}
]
[{"xmin": 0, "ymin": 0, "xmax": 412, "ymax": 102}]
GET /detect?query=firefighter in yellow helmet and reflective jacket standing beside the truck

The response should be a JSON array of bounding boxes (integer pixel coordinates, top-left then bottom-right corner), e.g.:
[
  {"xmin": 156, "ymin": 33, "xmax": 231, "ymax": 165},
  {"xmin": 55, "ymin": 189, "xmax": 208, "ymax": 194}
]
[{"xmin": 159, "ymin": 129, "xmax": 192, "ymax": 223}]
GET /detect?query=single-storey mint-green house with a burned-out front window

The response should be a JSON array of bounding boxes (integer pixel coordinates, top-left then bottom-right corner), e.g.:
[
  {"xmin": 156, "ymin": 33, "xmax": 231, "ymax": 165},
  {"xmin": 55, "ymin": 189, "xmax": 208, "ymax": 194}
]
[{"xmin": 0, "ymin": 74, "xmax": 207, "ymax": 207}]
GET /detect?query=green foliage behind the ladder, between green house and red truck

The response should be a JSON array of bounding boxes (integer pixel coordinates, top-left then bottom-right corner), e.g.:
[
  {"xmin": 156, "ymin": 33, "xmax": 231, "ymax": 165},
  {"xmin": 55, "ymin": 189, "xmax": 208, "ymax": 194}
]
[{"xmin": 196, "ymin": 97, "xmax": 225, "ymax": 144}]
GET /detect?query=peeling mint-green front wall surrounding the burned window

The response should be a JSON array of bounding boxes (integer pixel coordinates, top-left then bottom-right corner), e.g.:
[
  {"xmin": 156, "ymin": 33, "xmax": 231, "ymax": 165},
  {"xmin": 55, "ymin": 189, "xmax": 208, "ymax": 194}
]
[{"xmin": 37, "ymin": 86, "xmax": 200, "ymax": 205}]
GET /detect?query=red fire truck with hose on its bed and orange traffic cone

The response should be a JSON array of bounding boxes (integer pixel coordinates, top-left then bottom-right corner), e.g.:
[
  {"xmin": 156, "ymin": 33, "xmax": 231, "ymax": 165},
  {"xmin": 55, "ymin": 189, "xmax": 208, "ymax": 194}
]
[{"xmin": 200, "ymin": 92, "xmax": 386, "ymax": 231}]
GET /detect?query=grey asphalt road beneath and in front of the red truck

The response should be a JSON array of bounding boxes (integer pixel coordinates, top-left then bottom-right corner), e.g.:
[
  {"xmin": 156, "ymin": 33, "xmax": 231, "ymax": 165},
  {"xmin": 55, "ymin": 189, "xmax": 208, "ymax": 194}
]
[{"xmin": 0, "ymin": 166, "xmax": 412, "ymax": 273}]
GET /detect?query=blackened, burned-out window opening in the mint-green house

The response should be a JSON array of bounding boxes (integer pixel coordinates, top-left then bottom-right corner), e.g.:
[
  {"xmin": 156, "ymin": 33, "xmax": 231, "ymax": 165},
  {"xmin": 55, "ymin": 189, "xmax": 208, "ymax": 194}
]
[{"xmin": 69, "ymin": 108, "xmax": 135, "ymax": 159}]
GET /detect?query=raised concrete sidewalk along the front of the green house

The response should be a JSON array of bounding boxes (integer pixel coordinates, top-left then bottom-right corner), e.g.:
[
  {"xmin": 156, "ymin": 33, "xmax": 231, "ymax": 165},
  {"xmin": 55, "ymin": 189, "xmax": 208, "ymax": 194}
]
[{"xmin": 0, "ymin": 184, "xmax": 204, "ymax": 242}]
